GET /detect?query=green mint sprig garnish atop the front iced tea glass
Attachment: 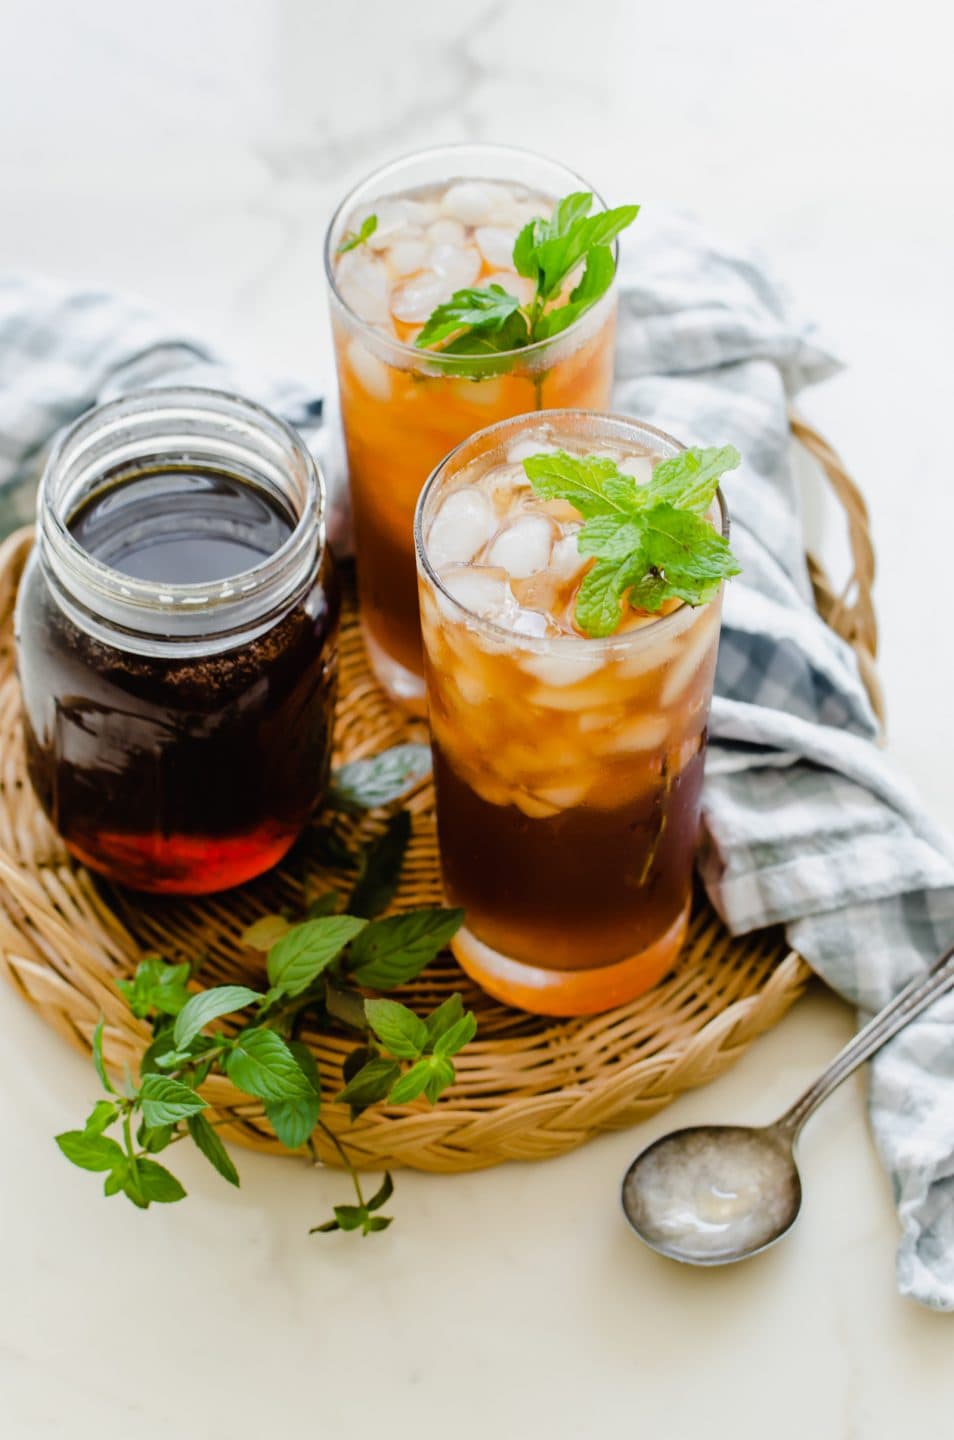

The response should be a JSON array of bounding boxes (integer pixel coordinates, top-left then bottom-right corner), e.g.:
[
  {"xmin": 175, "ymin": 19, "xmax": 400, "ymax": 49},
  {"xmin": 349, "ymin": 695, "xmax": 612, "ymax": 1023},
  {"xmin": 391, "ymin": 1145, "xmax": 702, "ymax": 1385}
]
[{"xmin": 523, "ymin": 445, "xmax": 741, "ymax": 638}]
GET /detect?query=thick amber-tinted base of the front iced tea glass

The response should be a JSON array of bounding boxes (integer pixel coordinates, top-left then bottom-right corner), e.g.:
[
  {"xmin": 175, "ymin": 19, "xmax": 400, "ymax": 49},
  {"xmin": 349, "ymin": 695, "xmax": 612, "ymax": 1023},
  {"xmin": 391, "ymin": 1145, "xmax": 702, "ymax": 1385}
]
[{"xmin": 451, "ymin": 901, "xmax": 692, "ymax": 1018}]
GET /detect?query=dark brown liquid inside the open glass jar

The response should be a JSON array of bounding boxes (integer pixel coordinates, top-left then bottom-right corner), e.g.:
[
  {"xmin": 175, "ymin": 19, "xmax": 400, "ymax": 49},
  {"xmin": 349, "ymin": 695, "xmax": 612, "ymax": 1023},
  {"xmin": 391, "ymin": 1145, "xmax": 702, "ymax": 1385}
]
[{"xmin": 19, "ymin": 464, "xmax": 339, "ymax": 894}]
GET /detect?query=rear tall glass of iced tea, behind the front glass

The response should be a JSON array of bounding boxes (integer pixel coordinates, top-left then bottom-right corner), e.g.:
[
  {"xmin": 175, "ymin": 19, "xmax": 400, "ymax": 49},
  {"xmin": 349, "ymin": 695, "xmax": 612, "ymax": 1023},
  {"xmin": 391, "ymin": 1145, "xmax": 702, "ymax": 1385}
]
[{"xmin": 326, "ymin": 145, "xmax": 636, "ymax": 711}]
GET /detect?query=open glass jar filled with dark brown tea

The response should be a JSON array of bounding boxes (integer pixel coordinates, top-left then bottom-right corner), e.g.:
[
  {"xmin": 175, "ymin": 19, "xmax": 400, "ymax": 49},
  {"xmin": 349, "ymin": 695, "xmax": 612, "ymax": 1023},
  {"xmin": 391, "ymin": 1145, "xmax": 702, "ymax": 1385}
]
[{"xmin": 16, "ymin": 389, "xmax": 339, "ymax": 894}]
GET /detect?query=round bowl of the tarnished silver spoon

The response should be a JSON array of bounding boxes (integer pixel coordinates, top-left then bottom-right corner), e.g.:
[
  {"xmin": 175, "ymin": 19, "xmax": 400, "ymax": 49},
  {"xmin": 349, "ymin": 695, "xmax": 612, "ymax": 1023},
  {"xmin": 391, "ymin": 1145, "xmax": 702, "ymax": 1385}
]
[{"xmin": 623, "ymin": 1125, "xmax": 801, "ymax": 1266}]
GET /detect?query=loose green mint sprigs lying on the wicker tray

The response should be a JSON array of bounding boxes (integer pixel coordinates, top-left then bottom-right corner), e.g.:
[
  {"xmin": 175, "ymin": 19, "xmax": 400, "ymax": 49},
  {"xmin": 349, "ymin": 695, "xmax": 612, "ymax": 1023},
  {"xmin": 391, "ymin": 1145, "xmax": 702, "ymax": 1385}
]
[{"xmin": 56, "ymin": 746, "xmax": 477, "ymax": 1236}]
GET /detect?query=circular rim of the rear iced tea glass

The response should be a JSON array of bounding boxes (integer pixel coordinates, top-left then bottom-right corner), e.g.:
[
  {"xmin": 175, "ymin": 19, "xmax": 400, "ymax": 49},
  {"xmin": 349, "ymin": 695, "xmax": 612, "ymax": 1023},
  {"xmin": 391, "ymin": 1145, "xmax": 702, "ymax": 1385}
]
[{"xmin": 324, "ymin": 141, "xmax": 620, "ymax": 369}]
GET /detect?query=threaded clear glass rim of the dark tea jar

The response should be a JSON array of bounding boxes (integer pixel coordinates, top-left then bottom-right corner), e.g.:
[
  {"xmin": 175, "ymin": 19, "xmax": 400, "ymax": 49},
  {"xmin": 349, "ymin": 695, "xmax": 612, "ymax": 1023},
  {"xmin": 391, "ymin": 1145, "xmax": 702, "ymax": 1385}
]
[{"xmin": 36, "ymin": 386, "xmax": 327, "ymax": 615}]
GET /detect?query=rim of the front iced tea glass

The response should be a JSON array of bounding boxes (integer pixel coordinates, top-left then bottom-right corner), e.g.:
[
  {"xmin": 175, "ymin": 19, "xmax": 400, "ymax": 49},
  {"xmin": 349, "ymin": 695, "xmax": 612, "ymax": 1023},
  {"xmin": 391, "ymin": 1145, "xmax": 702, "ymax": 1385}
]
[{"xmin": 414, "ymin": 408, "xmax": 731, "ymax": 655}]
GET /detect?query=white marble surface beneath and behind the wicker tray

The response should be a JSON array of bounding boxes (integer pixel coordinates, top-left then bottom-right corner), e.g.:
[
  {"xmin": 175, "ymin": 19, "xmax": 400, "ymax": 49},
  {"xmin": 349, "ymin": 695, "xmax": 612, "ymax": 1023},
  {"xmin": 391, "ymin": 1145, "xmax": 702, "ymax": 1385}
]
[{"xmin": 0, "ymin": 0, "xmax": 954, "ymax": 1440}]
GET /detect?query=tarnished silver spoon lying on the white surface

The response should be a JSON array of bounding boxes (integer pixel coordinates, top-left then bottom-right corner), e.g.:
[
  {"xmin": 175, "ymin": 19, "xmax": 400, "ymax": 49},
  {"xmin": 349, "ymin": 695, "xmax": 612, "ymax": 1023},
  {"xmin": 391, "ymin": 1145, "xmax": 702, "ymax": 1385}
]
[{"xmin": 623, "ymin": 946, "xmax": 954, "ymax": 1266}]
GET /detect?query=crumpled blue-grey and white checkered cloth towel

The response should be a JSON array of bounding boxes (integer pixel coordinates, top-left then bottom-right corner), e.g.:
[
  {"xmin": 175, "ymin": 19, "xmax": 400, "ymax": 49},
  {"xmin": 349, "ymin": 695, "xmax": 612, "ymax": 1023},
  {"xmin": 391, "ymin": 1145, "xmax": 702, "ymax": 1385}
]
[{"xmin": 0, "ymin": 213, "xmax": 954, "ymax": 1309}]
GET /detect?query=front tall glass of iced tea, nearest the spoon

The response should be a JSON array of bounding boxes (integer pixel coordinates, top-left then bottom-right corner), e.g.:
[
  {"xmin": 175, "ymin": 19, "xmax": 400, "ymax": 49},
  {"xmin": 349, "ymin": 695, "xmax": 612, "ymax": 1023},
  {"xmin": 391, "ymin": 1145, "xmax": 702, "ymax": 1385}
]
[{"xmin": 415, "ymin": 410, "xmax": 738, "ymax": 1015}]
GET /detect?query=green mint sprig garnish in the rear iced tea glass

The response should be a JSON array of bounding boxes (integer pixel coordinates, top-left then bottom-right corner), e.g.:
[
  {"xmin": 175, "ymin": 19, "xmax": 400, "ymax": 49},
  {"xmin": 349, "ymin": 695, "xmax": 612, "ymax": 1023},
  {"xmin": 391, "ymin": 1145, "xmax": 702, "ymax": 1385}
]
[{"xmin": 414, "ymin": 190, "xmax": 640, "ymax": 357}]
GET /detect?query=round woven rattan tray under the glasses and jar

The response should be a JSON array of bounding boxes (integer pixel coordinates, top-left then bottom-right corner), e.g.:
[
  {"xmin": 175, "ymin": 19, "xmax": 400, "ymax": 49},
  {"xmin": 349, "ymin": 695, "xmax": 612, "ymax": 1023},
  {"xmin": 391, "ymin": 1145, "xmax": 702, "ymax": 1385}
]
[{"xmin": 0, "ymin": 420, "xmax": 878, "ymax": 1171}]
